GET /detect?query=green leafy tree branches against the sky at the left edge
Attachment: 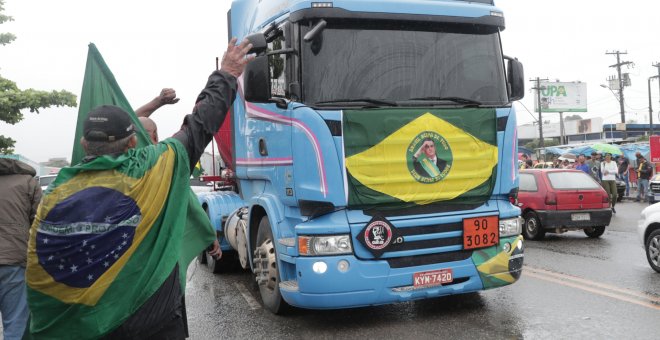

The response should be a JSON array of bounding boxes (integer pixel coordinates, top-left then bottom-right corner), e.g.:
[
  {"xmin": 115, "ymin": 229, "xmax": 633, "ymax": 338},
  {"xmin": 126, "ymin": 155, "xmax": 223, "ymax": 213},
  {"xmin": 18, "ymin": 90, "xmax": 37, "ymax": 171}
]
[{"xmin": 0, "ymin": 0, "xmax": 78, "ymax": 154}]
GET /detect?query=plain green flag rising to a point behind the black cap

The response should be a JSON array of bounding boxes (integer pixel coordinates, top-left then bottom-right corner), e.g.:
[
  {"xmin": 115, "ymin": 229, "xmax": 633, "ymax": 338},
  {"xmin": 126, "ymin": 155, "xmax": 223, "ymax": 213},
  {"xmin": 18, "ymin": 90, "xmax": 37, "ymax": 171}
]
[{"xmin": 71, "ymin": 44, "xmax": 151, "ymax": 164}]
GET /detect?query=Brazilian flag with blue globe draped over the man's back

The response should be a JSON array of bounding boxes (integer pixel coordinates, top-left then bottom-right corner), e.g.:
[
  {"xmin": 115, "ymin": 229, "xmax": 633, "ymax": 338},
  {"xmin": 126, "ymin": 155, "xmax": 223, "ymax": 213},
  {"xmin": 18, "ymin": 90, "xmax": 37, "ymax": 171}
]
[{"xmin": 26, "ymin": 46, "xmax": 215, "ymax": 339}]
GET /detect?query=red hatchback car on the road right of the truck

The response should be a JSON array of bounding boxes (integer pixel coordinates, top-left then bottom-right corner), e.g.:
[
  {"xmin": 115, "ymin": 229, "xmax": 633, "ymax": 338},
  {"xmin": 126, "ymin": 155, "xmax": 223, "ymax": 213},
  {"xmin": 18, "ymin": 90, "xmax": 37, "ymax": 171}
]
[{"xmin": 518, "ymin": 169, "xmax": 612, "ymax": 240}]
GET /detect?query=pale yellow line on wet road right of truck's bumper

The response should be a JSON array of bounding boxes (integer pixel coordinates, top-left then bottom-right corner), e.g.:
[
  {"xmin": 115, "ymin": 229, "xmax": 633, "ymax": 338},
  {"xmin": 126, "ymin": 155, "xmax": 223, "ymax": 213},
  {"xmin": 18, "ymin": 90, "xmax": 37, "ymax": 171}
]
[{"xmin": 523, "ymin": 265, "xmax": 660, "ymax": 311}]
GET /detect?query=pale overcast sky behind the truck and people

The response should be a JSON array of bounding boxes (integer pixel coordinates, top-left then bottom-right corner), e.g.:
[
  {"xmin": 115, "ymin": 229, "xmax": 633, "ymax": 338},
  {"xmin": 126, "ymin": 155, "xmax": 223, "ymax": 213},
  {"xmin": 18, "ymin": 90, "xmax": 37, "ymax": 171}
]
[{"xmin": 0, "ymin": 0, "xmax": 660, "ymax": 162}]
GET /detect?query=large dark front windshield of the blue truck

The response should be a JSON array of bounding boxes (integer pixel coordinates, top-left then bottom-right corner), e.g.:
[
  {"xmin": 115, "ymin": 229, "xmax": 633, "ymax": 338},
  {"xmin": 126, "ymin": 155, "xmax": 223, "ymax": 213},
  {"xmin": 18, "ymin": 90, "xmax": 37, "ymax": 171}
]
[{"xmin": 302, "ymin": 21, "xmax": 508, "ymax": 106}]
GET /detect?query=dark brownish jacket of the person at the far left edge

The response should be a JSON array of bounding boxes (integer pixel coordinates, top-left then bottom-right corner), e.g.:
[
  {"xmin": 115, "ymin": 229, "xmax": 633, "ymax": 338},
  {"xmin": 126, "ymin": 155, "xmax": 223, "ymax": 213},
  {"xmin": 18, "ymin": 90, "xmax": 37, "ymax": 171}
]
[{"xmin": 0, "ymin": 158, "xmax": 41, "ymax": 266}]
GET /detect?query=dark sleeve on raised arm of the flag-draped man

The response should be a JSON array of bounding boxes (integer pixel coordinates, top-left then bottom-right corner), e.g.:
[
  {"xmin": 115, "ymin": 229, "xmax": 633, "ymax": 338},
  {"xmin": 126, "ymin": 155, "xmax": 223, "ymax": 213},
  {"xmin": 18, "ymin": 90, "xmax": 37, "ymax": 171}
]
[{"xmin": 173, "ymin": 71, "xmax": 237, "ymax": 172}]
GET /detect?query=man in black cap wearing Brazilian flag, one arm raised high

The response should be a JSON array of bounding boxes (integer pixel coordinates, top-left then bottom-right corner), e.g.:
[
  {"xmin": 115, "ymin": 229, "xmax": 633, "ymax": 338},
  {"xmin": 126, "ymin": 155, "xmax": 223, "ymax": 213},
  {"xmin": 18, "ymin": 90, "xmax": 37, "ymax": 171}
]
[{"xmin": 26, "ymin": 39, "xmax": 252, "ymax": 339}]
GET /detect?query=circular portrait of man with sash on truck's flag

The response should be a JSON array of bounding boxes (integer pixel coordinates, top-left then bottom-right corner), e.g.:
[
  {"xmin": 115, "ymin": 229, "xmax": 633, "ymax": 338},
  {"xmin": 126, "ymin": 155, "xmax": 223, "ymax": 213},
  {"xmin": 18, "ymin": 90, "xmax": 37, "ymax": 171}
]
[{"xmin": 406, "ymin": 131, "xmax": 453, "ymax": 184}]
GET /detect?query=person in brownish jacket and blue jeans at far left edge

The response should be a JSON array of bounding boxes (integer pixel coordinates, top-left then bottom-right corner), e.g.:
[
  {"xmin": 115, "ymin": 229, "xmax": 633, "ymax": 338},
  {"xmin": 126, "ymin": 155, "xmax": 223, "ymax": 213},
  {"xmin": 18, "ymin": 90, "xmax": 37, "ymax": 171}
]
[{"xmin": 0, "ymin": 158, "xmax": 41, "ymax": 340}]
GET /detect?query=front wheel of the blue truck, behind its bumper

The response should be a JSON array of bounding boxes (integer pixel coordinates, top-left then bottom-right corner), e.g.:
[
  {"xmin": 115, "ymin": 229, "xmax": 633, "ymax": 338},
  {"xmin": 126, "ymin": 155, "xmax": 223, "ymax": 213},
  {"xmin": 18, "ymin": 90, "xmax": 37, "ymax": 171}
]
[{"xmin": 254, "ymin": 216, "xmax": 288, "ymax": 314}]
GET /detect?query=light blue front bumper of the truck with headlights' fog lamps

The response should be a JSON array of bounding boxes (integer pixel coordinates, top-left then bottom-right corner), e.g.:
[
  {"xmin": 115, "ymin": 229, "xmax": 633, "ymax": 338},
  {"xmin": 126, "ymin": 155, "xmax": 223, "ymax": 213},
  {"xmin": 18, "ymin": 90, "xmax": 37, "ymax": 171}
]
[{"xmin": 280, "ymin": 236, "xmax": 523, "ymax": 309}]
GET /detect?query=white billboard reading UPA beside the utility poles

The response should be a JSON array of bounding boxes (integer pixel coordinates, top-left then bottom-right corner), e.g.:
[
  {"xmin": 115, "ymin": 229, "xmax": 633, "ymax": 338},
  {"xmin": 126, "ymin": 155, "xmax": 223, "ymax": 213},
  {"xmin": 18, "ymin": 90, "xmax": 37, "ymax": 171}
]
[{"xmin": 534, "ymin": 82, "xmax": 587, "ymax": 112}]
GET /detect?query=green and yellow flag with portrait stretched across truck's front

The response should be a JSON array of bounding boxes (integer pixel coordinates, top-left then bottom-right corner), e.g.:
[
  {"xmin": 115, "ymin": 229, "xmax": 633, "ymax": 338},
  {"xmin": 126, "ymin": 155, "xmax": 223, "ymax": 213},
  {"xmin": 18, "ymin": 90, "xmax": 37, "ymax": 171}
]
[{"xmin": 343, "ymin": 108, "xmax": 498, "ymax": 209}]
